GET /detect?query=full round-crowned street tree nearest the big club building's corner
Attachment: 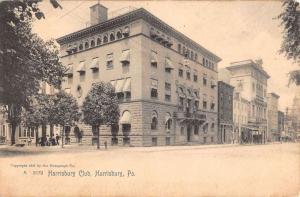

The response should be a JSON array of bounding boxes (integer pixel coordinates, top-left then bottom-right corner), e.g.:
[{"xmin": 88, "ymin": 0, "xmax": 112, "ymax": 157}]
[{"xmin": 82, "ymin": 82, "xmax": 120, "ymax": 149}]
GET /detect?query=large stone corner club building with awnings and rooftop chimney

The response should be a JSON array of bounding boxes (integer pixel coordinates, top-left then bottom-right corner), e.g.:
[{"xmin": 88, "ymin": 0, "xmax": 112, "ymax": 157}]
[{"xmin": 57, "ymin": 4, "xmax": 221, "ymax": 146}]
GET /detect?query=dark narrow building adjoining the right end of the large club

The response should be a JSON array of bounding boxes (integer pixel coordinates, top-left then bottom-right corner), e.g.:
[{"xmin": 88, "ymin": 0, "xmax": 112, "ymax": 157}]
[{"xmin": 218, "ymin": 81, "xmax": 235, "ymax": 144}]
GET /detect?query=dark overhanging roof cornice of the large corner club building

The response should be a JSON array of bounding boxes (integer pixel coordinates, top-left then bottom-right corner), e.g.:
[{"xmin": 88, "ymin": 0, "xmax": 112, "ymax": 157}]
[{"xmin": 57, "ymin": 8, "xmax": 222, "ymax": 62}]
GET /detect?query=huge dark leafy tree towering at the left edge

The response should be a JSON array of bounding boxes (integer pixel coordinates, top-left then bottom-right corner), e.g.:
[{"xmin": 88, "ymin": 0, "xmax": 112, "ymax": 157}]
[{"xmin": 0, "ymin": 0, "xmax": 66, "ymax": 144}]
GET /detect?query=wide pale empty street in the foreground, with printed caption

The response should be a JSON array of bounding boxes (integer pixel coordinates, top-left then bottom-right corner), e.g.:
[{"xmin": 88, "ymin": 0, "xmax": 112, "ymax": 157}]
[{"xmin": 0, "ymin": 143, "xmax": 300, "ymax": 196}]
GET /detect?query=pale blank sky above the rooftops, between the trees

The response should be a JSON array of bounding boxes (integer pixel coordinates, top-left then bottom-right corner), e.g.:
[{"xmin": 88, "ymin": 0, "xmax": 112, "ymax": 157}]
[{"xmin": 33, "ymin": 0, "xmax": 299, "ymax": 111}]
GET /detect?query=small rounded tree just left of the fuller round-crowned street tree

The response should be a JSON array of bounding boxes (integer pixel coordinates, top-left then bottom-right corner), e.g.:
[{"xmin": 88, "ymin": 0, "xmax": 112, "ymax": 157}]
[{"xmin": 49, "ymin": 91, "xmax": 80, "ymax": 147}]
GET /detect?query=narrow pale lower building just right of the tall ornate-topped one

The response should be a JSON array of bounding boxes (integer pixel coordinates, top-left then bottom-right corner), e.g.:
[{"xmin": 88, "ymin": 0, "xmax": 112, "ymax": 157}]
[{"xmin": 267, "ymin": 92, "xmax": 280, "ymax": 142}]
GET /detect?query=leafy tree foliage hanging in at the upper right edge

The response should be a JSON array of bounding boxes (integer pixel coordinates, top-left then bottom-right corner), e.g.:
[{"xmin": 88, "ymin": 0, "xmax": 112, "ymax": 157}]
[{"xmin": 278, "ymin": 0, "xmax": 300, "ymax": 85}]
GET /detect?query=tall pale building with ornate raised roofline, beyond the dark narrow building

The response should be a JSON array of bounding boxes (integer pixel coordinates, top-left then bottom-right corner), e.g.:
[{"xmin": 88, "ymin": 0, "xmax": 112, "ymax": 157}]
[{"xmin": 227, "ymin": 60, "xmax": 270, "ymax": 143}]
